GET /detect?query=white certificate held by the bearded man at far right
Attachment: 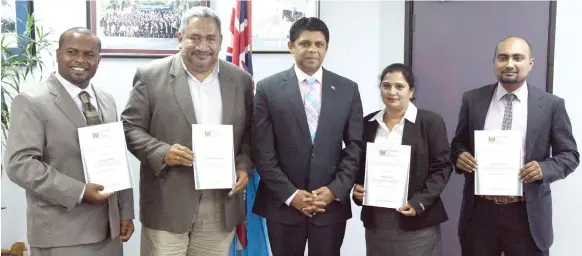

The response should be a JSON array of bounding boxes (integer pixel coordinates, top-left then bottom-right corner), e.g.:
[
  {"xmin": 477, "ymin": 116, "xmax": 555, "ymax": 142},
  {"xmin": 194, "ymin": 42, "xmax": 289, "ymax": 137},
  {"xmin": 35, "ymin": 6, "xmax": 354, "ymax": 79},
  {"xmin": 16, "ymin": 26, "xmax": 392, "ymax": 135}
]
[{"xmin": 475, "ymin": 130, "xmax": 523, "ymax": 196}]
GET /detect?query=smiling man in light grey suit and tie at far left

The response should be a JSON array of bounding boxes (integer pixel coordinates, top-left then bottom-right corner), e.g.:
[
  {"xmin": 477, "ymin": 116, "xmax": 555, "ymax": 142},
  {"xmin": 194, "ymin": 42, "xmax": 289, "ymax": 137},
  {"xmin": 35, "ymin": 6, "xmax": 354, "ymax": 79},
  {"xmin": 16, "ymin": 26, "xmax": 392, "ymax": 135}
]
[{"xmin": 5, "ymin": 28, "xmax": 134, "ymax": 256}]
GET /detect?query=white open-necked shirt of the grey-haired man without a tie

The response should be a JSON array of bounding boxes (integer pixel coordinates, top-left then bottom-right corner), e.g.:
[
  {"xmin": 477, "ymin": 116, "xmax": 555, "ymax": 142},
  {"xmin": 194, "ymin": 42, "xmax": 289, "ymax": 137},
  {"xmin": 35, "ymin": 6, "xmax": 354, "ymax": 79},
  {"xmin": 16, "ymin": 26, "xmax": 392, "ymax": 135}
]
[{"xmin": 182, "ymin": 60, "xmax": 222, "ymax": 124}]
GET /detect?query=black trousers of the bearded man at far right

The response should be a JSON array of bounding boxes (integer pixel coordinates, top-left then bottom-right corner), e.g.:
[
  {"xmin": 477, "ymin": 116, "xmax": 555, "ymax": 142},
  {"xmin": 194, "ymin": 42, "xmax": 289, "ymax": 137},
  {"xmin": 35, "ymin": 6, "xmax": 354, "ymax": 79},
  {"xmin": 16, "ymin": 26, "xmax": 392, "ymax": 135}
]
[{"xmin": 460, "ymin": 196, "xmax": 549, "ymax": 256}]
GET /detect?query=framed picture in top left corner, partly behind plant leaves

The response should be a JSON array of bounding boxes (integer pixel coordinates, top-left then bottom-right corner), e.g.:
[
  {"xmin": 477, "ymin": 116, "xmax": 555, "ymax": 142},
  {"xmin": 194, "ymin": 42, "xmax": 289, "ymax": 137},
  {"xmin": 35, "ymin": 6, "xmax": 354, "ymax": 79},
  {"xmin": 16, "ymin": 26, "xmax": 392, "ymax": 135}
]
[{"xmin": 0, "ymin": 0, "xmax": 36, "ymax": 54}]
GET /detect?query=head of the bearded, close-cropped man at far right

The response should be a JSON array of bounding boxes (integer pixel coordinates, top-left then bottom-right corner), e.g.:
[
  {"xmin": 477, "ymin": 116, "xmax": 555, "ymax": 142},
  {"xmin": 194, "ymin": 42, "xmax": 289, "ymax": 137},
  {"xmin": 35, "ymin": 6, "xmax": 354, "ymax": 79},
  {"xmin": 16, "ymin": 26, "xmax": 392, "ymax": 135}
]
[{"xmin": 493, "ymin": 38, "xmax": 534, "ymax": 85}]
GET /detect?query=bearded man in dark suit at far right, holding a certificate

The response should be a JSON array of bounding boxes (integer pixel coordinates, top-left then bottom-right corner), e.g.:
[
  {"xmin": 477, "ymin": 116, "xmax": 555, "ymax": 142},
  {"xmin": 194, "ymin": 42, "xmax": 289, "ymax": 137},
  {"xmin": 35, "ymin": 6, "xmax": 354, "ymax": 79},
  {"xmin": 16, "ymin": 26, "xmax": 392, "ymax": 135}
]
[{"xmin": 451, "ymin": 37, "xmax": 579, "ymax": 256}]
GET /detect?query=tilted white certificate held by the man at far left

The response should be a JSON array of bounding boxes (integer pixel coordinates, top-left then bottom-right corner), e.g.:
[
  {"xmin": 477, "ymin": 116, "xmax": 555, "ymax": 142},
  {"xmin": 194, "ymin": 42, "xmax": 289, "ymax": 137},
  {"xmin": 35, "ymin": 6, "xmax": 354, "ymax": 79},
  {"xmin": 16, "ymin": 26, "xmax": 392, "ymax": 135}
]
[{"xmin": 78, "ymin": 122, "xmax": 135, "ymax": 193}]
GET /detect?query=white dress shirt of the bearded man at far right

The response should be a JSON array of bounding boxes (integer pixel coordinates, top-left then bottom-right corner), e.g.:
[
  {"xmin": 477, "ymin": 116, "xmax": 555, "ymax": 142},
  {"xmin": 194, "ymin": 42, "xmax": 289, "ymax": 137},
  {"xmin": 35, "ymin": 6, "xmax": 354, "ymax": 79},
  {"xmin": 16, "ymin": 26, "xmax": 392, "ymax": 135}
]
[{"xmin": 485, "ymin": 82, "xmax": 528, "ymax": 163}]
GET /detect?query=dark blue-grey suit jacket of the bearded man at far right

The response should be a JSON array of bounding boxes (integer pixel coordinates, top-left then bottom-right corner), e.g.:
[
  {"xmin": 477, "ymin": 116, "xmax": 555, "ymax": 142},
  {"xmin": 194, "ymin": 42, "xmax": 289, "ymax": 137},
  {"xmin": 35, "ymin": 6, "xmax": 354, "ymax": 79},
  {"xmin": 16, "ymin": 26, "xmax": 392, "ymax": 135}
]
[{"xmin": 451, "ymin": 83, "xmax": 580, "ymax": 250}]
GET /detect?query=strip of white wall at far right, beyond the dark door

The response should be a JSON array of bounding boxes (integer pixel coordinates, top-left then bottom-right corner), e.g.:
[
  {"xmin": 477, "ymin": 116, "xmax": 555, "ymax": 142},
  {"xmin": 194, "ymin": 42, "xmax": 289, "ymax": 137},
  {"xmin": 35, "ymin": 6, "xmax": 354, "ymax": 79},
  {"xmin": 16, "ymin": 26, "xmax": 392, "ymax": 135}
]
[{"xmin": 550, "ymin": 0, "xmax": 582, "ymax": 256}]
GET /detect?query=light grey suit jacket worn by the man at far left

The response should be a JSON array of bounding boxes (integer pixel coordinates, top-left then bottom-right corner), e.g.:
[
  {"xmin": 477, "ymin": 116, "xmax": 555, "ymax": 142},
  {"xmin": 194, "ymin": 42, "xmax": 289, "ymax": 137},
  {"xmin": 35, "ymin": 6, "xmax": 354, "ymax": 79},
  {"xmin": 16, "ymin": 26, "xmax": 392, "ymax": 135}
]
[{"xmin": 5, "ymin": 75, "xmax": 134, "ymax": 247}]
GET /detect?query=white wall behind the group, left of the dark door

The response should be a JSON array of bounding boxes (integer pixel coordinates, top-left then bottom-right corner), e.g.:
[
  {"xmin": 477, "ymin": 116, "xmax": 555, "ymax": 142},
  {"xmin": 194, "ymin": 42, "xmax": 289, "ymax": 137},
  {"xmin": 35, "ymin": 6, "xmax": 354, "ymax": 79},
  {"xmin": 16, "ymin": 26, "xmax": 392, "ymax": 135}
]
[{"xmin": 1, "ymin": 0, "xmax": 404, "ymax": 256}]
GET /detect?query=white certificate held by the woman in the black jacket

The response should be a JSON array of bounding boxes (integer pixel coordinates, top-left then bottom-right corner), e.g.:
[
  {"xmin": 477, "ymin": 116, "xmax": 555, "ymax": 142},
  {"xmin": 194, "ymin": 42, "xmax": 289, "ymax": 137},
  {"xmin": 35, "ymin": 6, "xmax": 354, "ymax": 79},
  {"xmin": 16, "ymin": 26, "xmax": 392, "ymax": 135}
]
[{"xmin": 363, "ymin": 143, "xmax": 411, "ymax": 209}]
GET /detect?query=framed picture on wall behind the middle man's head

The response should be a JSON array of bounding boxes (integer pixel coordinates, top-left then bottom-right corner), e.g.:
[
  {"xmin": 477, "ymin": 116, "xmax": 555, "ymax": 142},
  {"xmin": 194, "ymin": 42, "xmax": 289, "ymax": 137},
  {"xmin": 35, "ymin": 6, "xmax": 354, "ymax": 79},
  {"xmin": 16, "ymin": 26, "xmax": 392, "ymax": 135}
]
[{"xmin": 252, "ymin": 0, "xmax": 319, "ymax": 53}]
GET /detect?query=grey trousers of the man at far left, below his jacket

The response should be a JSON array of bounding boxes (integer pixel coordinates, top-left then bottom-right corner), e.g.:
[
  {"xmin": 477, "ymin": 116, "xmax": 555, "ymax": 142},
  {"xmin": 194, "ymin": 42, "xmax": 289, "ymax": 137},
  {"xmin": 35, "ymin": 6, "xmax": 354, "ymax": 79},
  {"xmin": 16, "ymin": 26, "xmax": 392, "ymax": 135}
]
[{"xmin": 30, "ymin": 236, "xmax": 123, "ymax": 256}]
